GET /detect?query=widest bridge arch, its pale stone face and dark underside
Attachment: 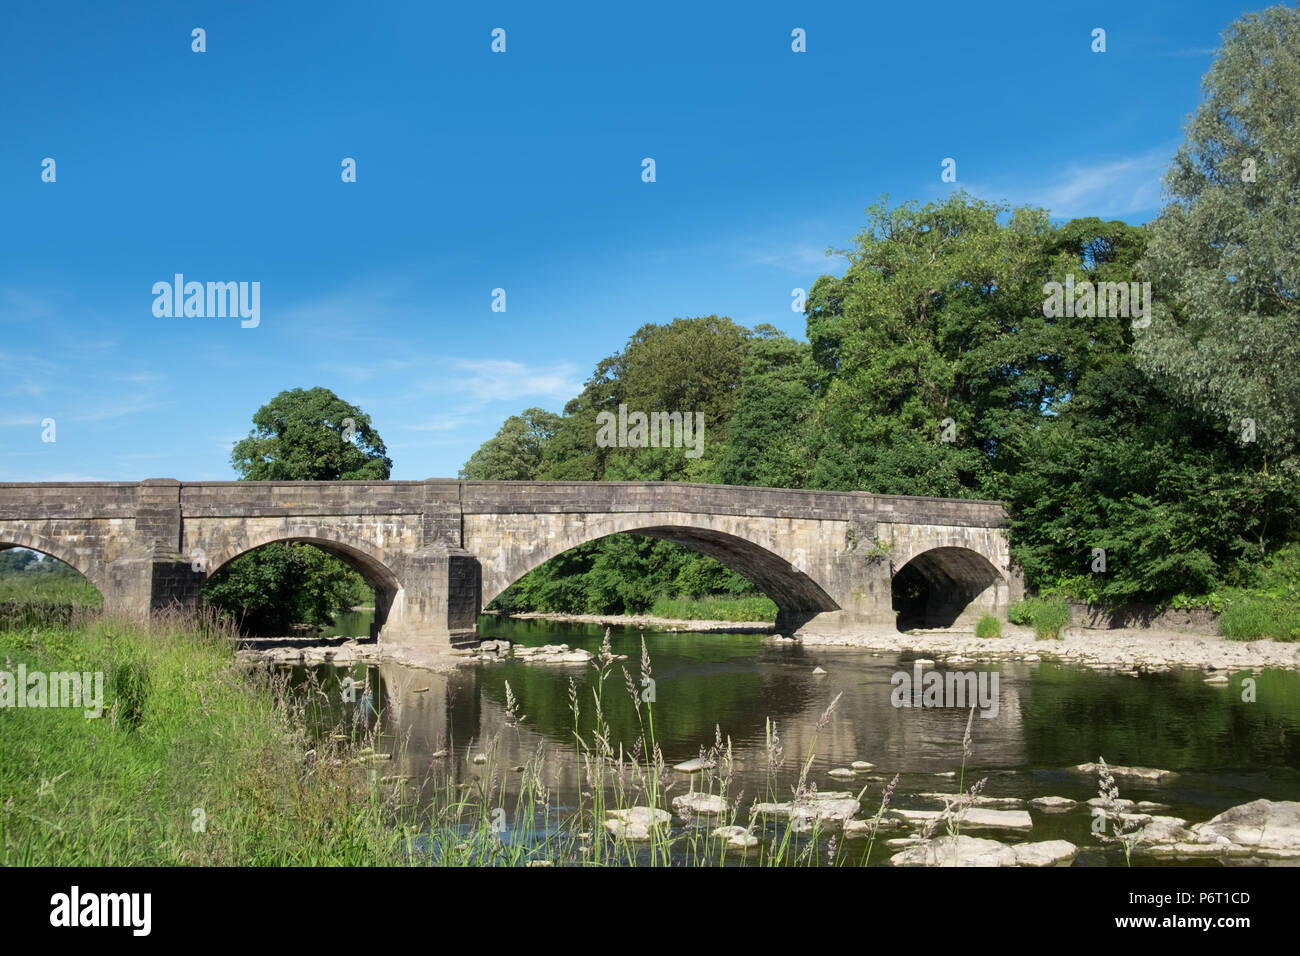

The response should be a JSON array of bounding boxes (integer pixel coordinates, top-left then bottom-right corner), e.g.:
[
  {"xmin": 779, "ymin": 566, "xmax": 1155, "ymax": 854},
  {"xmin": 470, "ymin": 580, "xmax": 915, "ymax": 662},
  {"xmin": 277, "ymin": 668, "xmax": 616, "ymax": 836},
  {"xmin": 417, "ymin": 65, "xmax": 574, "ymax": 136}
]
[{"xmin": 478, "ymin": 514, "xmax": 840, "ymax": 630}]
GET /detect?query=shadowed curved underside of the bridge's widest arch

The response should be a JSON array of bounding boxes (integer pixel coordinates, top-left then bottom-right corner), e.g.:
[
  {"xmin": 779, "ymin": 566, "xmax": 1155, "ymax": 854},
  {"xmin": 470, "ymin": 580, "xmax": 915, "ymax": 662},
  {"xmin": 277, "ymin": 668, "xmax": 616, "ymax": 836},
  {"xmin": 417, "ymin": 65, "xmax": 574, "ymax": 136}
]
[{"xmin": 482, "ymin": 524, "xmax": 840, "ymax": 632}]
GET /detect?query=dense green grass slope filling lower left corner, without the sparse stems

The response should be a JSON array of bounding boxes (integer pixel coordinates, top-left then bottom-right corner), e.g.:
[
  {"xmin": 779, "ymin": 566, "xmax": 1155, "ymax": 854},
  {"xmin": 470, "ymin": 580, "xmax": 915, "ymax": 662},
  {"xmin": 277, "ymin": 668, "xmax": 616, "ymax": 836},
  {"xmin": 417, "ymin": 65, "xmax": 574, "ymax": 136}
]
[{"xmin": 0, "ymin": 619, "xmax": 416, "ymax": 866}]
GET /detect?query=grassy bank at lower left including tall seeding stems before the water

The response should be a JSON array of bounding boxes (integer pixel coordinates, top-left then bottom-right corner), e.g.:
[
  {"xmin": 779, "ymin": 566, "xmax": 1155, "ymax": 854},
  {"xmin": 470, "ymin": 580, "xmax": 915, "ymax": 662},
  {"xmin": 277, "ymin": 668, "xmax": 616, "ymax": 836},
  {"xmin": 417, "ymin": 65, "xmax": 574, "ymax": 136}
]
[{"xmin": 0, "ymin": 618, "xmax": 915, "ymax": 866}]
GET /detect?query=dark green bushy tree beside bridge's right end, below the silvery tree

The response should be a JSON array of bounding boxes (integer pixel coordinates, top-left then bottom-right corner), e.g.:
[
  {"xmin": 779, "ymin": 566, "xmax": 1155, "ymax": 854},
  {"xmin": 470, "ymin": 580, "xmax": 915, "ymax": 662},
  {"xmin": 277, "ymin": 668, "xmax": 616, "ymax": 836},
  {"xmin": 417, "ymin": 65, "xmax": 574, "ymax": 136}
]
[{"xmin": 993, "ymin": 358, "xmax": 1300, "ymax": 604}]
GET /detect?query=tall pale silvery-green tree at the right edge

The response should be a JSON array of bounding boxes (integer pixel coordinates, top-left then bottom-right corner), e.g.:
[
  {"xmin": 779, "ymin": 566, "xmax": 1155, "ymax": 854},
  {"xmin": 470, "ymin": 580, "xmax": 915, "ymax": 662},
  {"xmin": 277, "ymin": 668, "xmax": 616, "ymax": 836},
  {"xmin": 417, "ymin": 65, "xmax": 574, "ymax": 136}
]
[{"xmin": 1136, "ymin": 5, "xmax": 1300, "ymax": 470}]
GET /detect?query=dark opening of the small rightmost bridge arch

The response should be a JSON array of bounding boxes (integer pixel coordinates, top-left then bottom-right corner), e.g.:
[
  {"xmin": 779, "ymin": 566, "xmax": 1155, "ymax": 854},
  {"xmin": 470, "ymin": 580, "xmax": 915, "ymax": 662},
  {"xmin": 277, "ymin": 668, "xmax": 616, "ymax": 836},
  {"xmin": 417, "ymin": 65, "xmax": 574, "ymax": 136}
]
[{"xmin": 891, "ymin": 548, "xmax": 1006, "ymax": 631}]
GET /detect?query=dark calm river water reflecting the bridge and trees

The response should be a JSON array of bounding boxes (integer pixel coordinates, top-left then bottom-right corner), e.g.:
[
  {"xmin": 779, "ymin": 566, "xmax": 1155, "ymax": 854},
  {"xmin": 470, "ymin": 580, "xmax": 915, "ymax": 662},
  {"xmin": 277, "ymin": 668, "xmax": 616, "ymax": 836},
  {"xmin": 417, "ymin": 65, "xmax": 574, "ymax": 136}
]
[{"xmin": 294, "ymin": 617, "xmax": 1300, "ymax": 865}]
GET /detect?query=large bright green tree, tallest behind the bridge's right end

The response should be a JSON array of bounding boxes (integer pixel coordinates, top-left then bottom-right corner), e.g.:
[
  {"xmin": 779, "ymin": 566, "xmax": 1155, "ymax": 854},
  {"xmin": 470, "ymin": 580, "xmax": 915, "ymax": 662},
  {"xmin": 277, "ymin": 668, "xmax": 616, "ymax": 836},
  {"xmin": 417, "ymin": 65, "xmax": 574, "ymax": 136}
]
[{"xmin": 807, "ymin": 193, "xmax": 1140, "ymax": 497}]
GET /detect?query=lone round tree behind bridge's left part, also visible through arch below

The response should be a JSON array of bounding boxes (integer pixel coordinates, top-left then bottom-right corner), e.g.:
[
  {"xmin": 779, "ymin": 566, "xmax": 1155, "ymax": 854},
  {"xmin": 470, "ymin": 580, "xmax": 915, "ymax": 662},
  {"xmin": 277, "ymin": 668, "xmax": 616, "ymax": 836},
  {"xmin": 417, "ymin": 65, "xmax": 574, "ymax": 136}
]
[{"xmin": 203, "ymin": 388, "xmax": 382, "ymax": 635}]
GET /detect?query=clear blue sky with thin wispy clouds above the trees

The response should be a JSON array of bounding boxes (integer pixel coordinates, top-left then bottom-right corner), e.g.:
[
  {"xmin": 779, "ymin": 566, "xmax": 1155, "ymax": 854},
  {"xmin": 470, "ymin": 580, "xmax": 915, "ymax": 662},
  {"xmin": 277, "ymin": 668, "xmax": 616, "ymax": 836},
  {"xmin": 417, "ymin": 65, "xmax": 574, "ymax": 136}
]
[{"xmin": 0, "ymin": 0, "xmax": 1260, "ymax": 481}]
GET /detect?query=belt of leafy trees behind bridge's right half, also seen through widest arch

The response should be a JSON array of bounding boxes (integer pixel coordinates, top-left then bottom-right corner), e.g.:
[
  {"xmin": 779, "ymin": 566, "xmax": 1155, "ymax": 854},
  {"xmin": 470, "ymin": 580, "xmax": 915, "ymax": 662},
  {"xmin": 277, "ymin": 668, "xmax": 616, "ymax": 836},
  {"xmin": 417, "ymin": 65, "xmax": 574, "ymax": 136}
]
[{"xmin": 467, "ymin": 16, "xmax": 1300, "ymax": 621}]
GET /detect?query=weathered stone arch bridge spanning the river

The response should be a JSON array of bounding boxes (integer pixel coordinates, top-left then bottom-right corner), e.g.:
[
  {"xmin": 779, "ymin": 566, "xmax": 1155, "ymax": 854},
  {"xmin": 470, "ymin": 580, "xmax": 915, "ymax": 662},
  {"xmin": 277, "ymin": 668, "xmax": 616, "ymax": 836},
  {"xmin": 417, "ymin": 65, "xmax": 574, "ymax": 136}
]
[{"xmin": 0, "ymin": 479, "xmax": 1023, "ymax": 646}]
